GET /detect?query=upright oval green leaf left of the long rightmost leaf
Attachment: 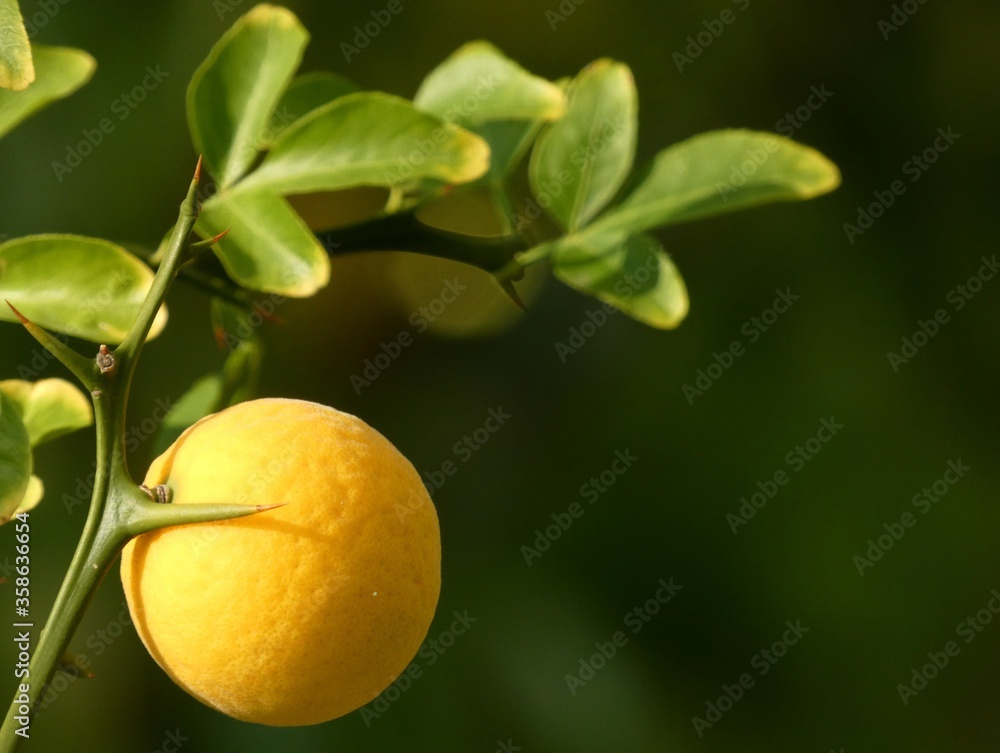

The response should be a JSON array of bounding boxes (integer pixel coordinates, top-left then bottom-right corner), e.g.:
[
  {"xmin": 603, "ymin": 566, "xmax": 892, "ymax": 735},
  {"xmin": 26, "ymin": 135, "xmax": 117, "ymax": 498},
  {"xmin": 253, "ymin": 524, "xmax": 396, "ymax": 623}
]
[{"xmin": 528, "ymin": 59, "xmax": 639, "ymax": 232}]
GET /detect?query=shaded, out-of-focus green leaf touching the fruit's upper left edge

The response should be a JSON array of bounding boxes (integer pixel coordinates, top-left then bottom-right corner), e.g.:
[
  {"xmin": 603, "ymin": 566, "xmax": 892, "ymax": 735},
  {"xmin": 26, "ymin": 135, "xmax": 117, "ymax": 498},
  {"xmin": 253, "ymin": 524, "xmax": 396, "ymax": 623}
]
[{"xmin": 153, "ymin": 340, "xmax": 260, "ymax": 456}]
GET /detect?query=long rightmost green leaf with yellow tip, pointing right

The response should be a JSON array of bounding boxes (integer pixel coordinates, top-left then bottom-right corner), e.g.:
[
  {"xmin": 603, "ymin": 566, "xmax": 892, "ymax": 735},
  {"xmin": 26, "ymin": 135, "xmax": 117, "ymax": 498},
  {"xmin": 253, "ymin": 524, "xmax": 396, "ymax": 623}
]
[{"xmin": 592, "ymin": 130, "xmax": 840, "ymax": 233}]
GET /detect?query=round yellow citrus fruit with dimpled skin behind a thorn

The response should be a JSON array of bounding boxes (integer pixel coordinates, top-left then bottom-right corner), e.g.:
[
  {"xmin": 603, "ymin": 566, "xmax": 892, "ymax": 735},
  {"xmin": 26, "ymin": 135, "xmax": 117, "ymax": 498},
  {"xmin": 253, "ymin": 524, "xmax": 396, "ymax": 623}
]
[{"xmin": 121, "ymin": 399, "xmax": 441, "ymax": 726}]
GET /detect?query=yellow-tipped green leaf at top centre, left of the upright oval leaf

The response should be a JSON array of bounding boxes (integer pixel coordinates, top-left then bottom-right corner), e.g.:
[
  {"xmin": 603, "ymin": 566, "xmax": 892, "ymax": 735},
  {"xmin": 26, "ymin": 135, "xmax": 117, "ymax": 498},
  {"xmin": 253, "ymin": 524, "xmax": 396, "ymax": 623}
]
[{"xmin": 413, "ymin": 41, "xmax": 565, "ymax": 125}]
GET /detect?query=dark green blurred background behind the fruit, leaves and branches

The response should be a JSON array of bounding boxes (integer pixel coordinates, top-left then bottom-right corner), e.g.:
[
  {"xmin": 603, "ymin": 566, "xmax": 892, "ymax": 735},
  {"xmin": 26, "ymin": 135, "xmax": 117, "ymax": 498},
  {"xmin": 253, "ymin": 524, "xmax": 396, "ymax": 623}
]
[{"xmin": 0, "ymin": 0, "xmax": 1000, "ymax": 753}]
